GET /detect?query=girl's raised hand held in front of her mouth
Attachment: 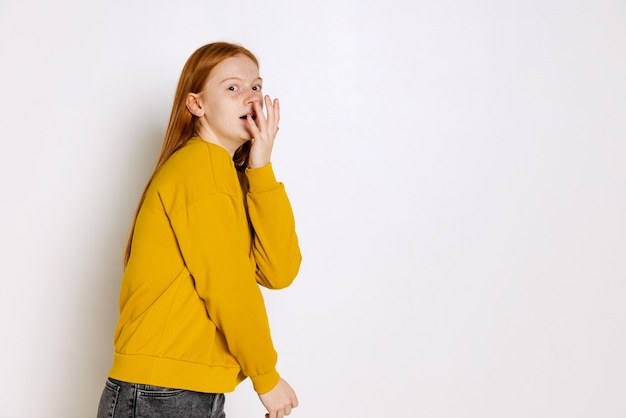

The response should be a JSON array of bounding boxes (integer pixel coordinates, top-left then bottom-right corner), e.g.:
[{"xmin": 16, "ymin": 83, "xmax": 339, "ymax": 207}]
[{"xmin": 248, "ymin": 96, "xmax": 280, "ymax": 168}]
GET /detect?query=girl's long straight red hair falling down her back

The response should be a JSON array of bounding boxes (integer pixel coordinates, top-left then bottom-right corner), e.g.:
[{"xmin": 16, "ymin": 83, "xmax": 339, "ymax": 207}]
[{"xmin": 124, "ymin": 42, "xmax": 259, "ymax": 266}]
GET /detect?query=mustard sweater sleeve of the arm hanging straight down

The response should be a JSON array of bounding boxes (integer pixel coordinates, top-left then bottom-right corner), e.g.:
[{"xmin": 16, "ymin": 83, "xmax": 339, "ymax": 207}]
[{"xmin": 170, "ymin": 193, "xmax": 279, "ymax": 393}]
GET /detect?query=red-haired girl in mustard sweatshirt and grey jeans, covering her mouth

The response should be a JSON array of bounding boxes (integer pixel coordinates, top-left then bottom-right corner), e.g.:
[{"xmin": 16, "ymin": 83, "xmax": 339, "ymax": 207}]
[{"xmin": 98, "ymin": 42, "xmax": 301, "ymax": 418}]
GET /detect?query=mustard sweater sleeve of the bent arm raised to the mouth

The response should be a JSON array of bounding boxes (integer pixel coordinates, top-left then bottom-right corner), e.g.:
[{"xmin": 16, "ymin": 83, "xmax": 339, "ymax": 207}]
[{"xmin": 246, "ymin": 163, "xmax": 302, "ymax": 289}]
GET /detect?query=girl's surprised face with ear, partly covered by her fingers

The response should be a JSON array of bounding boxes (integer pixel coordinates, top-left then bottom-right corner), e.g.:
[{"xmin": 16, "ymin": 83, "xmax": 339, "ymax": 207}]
[{"xmin": 187, "ymin": 55, "xmax": 263, "ymax": 155}]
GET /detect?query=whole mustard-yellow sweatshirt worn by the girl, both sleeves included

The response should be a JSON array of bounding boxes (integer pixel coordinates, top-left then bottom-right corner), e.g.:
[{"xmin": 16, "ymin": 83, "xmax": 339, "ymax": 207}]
[{"xmin": 109, "ymin": 138, "xmax": 301, "ymax": 393}]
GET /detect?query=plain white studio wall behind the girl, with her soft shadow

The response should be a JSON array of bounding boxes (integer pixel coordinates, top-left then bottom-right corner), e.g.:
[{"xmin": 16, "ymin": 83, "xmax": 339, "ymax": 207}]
[{"xmin": 0, "ymin": 0, "xmax": 626, "ymax": 418}]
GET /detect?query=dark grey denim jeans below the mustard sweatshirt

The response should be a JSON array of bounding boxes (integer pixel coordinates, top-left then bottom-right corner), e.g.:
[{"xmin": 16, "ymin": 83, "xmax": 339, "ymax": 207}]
[{"xmin": 97, "ymin": 378, "xmax": 226, "ymax": 418}]
